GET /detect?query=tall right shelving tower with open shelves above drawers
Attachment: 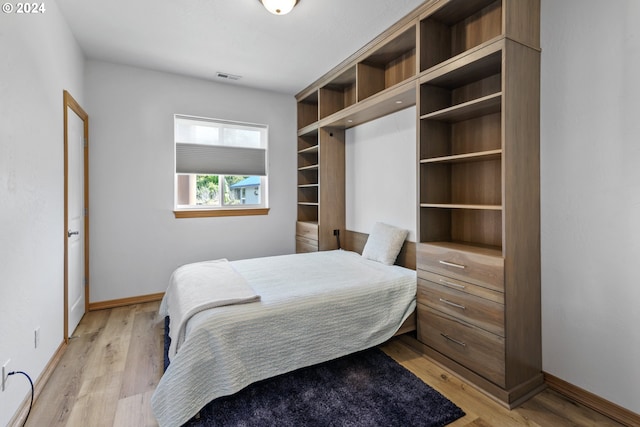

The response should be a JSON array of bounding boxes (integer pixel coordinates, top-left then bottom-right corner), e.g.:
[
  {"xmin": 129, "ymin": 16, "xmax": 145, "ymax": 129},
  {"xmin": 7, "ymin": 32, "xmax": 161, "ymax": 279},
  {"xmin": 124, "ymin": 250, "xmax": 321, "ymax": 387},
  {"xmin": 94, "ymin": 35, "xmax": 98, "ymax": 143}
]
[{"xmin": 417, "ymin": 0, "xmax": 543, "ymax": 407}]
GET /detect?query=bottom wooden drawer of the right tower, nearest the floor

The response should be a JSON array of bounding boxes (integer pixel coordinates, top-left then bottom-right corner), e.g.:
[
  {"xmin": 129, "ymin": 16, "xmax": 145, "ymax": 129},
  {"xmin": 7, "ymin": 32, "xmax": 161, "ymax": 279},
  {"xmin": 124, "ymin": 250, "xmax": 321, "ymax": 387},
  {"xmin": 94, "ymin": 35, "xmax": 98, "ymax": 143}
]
[{"xmin": 418, "ymin": 304, "xmax": 505, "ymax": 387}]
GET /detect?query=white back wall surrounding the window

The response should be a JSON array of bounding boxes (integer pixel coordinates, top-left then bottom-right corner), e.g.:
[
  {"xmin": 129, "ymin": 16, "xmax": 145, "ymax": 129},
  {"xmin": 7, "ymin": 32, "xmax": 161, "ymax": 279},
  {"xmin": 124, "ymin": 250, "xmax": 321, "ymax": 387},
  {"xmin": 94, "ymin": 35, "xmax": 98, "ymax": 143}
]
[{"xmin": 85, "ymin": 61, "xmax": 296, "ymax": 302}]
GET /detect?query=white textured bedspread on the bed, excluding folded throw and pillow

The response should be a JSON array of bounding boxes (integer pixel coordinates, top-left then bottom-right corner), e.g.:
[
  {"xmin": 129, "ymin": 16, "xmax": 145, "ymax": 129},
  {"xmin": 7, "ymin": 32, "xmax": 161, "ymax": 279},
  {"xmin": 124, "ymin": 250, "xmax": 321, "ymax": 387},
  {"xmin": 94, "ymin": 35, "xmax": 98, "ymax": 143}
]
[{"xmin": 151, "ymin": 250, "xmax": 416, "ymax": 427}]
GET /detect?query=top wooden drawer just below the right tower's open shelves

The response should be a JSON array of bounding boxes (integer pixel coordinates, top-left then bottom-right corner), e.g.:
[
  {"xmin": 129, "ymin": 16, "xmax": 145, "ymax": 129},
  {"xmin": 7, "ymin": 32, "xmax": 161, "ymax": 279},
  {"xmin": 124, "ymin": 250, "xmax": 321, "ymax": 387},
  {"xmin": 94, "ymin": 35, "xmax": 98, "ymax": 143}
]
[{"xmin": 416, "ymin": 243, "xmax": 504, "ymax": 292}]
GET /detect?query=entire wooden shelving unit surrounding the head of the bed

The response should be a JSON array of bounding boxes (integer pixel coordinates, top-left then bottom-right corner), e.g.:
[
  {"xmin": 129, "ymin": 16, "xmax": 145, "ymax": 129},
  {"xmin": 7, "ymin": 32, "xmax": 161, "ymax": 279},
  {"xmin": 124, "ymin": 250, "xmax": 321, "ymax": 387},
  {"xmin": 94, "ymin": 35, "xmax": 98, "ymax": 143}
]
[{"xmin": 296, "ymin": 0, "xmax": 543, "ymax": 407}]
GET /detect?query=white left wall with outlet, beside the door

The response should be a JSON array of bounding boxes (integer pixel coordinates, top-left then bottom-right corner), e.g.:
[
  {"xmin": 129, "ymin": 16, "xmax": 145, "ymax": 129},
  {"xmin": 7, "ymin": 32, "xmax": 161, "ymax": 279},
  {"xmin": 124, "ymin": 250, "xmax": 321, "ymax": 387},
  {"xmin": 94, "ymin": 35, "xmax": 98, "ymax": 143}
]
[{"xmin": 0, "ymin": 2, "xmax": 84, "ymax": 426}]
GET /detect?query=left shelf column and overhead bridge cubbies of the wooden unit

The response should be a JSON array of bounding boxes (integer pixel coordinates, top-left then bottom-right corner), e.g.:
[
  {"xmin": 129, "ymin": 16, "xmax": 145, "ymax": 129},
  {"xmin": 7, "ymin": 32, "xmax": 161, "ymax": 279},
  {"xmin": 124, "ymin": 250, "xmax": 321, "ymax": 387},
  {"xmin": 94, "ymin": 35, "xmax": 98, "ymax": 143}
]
[{"xmin": 296, "ymin": 11, "xmax": 417, "ymax": 252}]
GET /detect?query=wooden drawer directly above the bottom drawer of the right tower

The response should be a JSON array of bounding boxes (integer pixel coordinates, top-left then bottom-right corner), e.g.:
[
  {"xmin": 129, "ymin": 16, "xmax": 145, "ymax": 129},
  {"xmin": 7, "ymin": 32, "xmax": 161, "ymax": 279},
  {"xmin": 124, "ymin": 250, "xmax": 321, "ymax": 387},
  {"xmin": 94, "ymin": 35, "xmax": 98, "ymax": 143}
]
[{"xmin": 417, "ymin": 278, "xmax": 504, "ymax": 337}]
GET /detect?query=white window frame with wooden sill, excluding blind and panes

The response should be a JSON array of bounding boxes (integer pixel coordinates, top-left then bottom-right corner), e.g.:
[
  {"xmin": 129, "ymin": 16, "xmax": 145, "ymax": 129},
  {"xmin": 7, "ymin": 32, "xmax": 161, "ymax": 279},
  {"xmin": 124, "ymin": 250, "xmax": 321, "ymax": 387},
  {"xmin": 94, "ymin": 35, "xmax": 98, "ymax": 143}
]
[{"xmin": 173, "ymin": 114, "xmax": 269, "ymax": 218}]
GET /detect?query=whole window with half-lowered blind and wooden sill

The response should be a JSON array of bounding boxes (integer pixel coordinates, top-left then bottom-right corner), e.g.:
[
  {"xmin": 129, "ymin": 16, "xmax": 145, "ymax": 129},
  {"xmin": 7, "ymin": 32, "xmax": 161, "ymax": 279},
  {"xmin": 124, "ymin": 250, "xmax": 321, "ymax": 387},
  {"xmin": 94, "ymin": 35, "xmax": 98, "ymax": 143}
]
[{"xmin": 174, "ymin": 115, "xmax": 268, "ymax": 217}]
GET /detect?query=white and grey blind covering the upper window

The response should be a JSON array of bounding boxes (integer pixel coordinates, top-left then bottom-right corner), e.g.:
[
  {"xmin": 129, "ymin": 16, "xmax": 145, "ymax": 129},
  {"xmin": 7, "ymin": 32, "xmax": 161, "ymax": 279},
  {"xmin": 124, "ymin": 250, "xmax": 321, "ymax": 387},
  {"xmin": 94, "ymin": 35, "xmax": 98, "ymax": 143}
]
[{"xmin": 175, "ymin": 115, "xmax": 268, "ymax": 176}]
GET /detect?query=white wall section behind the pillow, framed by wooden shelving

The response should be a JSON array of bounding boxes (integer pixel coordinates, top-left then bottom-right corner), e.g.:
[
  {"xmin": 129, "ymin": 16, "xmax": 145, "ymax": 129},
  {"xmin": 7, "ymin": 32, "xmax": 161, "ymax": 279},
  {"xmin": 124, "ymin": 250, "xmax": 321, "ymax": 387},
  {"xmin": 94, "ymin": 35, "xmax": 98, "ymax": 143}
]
[{"xmin": 345, "ymin": 107, "xmax": 417, "ymax": 242}]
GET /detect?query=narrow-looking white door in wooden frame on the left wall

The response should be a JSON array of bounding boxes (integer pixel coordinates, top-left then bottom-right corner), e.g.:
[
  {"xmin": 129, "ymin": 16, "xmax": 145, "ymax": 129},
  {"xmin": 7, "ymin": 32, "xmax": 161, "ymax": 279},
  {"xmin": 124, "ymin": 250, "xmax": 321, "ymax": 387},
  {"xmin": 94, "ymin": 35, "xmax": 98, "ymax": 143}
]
[{"xmin": 65, "ymin": 100, "xmax": 85, "ymax": 338}]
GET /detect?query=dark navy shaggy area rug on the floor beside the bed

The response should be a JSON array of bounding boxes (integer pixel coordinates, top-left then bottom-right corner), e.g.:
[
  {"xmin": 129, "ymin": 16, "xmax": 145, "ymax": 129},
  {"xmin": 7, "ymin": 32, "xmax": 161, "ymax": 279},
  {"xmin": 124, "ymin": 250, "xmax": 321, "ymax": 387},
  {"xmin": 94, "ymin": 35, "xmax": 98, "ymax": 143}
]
[{"xmin": 165, "ymin": 318, "xmax": 464, "ymax": 427}]
